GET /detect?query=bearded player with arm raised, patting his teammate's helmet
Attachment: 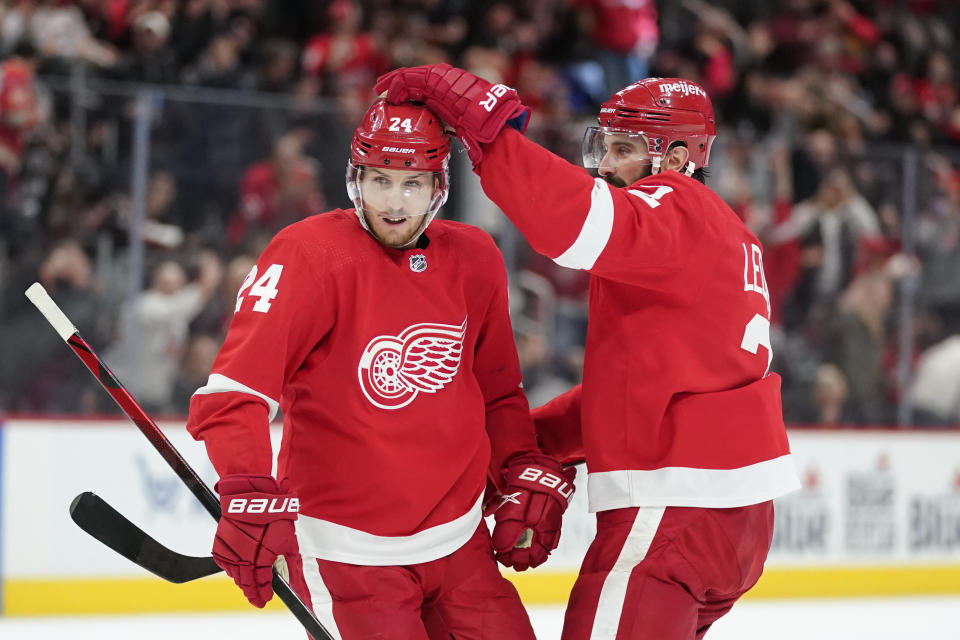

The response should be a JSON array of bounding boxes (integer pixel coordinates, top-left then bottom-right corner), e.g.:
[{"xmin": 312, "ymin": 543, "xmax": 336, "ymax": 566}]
[{"xmin": 376, "ymin": 65, "xmax": 799, "ymax": 640}]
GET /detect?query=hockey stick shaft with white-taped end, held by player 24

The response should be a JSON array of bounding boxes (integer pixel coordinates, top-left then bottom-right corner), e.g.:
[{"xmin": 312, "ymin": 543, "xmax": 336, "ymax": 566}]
[{"xmin": 26, "ymin": 282, "xmax": 333, "ymax": 640}]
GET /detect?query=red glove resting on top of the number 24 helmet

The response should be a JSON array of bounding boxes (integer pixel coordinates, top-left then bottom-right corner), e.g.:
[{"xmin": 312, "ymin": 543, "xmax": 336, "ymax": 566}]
[{"xmin": 374, "ymin": 63, "xmax": 530, "ymax": 168}]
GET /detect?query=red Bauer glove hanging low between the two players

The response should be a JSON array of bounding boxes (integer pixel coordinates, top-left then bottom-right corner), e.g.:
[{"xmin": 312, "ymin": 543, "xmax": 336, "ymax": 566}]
[{"xmin": 493, "ymin": 455, "xmax": 577, "ymax": 571}]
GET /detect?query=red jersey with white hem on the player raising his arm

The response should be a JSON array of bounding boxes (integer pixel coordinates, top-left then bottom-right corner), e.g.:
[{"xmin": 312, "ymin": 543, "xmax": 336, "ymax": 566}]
[{"xmin": 480, "ymin": 130, "xmax": 799, "ymax": 511}]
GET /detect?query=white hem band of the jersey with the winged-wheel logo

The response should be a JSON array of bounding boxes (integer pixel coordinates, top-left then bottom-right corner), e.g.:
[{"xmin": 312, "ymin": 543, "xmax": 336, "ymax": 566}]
[{"xmin": 296, "ymin": 493, "xmax": 483, "ymax": 567}]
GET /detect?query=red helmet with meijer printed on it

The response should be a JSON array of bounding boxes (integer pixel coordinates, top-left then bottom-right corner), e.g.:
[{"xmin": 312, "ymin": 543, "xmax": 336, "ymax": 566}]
[{"xmin": 583, "ymin": 78, "xmax": 717, "ymax": 174}]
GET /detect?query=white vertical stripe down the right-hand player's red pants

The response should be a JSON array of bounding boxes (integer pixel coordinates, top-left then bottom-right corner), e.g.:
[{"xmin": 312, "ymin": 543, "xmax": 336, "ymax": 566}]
[{"xmin": 590, "ymin": 507, "xmax": 666, "ymax": 640}]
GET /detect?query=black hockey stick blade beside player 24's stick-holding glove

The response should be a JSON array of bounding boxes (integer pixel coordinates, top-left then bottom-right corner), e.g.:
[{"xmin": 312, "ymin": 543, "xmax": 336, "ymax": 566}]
[{"xmin": 70, "ymin": 491, "xmax": 221, "ymax": 584}]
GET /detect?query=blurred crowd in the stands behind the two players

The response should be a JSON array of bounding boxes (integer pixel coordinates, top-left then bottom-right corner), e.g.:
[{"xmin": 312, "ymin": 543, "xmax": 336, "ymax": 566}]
[{"xmin": 0, "ymin": 0, "xmax": 960, "ymax": 427}]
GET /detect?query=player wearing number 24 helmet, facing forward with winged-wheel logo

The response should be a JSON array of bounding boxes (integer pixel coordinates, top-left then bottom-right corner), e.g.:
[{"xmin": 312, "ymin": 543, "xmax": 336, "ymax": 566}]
[{"xmin": 187, "ymin": 100, "xmax": 573, "ymax": 640}]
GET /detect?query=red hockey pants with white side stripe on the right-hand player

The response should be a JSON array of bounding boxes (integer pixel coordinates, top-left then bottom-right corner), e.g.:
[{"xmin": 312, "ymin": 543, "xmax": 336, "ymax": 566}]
[{"xmin": 561, "ymin": 502, "xmax": 773, "ymax": 640}]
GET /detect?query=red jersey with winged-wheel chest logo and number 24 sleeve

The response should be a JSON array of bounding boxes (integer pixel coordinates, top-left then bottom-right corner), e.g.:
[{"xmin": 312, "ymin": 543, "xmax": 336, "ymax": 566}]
[{"xmin": 187, "ymin": 210, "xmax": 536, "ymax": 564}]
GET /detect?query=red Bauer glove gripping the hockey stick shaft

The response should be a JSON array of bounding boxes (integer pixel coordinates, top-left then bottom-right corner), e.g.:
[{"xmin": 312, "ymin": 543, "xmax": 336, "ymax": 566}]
[{"xmin": 213, "ymin": 474, "xmax": 300, "ymax": 607}]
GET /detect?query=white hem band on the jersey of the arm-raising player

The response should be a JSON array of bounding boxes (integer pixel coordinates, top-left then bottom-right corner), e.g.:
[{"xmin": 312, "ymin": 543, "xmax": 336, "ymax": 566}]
[{"xmin": 587, "ymin": 454, "xmax": 800, "ymax": 512}]
